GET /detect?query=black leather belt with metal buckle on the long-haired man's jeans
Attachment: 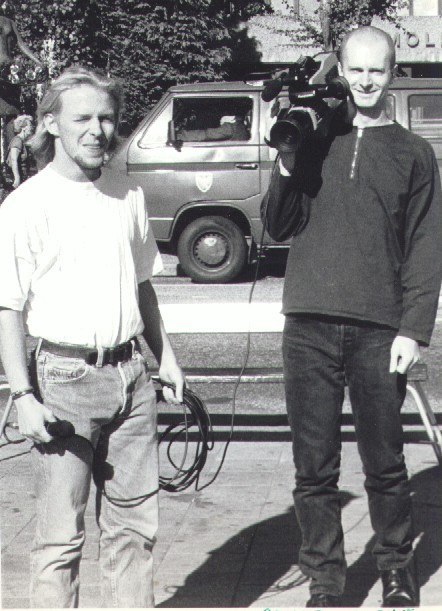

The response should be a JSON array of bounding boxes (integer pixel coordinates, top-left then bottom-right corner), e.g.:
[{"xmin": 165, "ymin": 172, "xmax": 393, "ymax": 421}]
[{"xmin": 40, "ymin": 337, "xmax": 139, "ymax": 367}]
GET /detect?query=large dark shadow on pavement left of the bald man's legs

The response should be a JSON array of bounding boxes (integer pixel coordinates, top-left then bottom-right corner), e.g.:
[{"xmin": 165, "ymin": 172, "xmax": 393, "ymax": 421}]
[{"xmin": 157, "ymin": 492, "xmax": 353, "ymax": 607}]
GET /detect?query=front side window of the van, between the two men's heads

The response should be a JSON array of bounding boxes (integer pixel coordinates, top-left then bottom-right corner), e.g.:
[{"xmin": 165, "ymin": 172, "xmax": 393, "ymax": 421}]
[{"xmin": 173, "ymin": 97, "xmax": 253, "ymax": 142}]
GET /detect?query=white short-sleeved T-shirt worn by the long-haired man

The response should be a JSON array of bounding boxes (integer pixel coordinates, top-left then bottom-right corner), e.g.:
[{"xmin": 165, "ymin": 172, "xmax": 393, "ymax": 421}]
[{"xmin": 0, "ymin": 164, "xmax": 162, "ymax": 347}]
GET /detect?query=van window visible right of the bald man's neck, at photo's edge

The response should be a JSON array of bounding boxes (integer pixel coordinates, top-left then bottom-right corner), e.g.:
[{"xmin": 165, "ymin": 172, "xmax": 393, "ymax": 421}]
[{"xmin": 408, "ymin": 93, "xmax": 442, "ymax": 138}]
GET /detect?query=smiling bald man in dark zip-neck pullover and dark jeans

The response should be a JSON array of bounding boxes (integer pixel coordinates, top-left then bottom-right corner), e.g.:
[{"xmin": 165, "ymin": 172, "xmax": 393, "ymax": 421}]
[{"xmin": 262, "ymin": 27, "xmax": 442, "ymax": 607}]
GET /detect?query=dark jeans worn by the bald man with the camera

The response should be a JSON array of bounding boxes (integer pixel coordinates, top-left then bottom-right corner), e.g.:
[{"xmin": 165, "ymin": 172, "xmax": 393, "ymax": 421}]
[{"xmin": 283, "ymin": 316, "xmax": 412, "ymax": 596}]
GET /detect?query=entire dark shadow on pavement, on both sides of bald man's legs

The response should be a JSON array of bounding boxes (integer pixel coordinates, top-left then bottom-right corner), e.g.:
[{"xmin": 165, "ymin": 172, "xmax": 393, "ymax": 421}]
[{"xmin": 158, "ymin": 467, "xmax": 442, "ymax": 607}]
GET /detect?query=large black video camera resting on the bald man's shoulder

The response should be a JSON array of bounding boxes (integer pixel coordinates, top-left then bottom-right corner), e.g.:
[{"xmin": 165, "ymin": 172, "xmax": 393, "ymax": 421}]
[{"xmin": 261, "ymin": 53, "xmax": 350, "ymax": 153}]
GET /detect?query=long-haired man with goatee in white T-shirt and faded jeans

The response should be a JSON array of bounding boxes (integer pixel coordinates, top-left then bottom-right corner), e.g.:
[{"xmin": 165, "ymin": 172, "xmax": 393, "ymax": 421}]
[{"xmin": 0, "ymin": 67, "xmax": 184, "ymax": 607}]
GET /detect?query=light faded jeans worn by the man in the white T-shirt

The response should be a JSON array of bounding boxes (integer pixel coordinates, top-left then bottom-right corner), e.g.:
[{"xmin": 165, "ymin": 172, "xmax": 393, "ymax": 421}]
[{"xmin": 31, "ymin": 344, "xmax": 158, "ymax": 607}]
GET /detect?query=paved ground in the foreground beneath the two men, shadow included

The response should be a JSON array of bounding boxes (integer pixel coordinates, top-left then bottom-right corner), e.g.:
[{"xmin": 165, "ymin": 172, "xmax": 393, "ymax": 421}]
[{"xmin": 0, "ymin": 430, "xmax": 442, "ymax": 609}]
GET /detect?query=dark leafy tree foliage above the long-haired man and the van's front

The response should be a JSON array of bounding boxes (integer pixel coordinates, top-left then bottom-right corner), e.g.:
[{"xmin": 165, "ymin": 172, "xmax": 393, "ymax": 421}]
[{"xmin": 7, "ymin": 0, "xmax": 270, "ymax": 125}]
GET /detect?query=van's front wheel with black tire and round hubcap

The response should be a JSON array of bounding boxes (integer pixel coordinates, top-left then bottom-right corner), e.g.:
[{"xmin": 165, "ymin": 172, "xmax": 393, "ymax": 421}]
[{"xmin": 177, "ymin": 216, "xmax": 247, "ymax": 284}]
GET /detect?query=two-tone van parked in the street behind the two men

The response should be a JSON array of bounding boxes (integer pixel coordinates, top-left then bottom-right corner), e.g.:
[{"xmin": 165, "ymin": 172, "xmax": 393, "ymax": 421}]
[{"xmin": 109, "ymin": 77, "xmax": 442, "ymax": 283}]
